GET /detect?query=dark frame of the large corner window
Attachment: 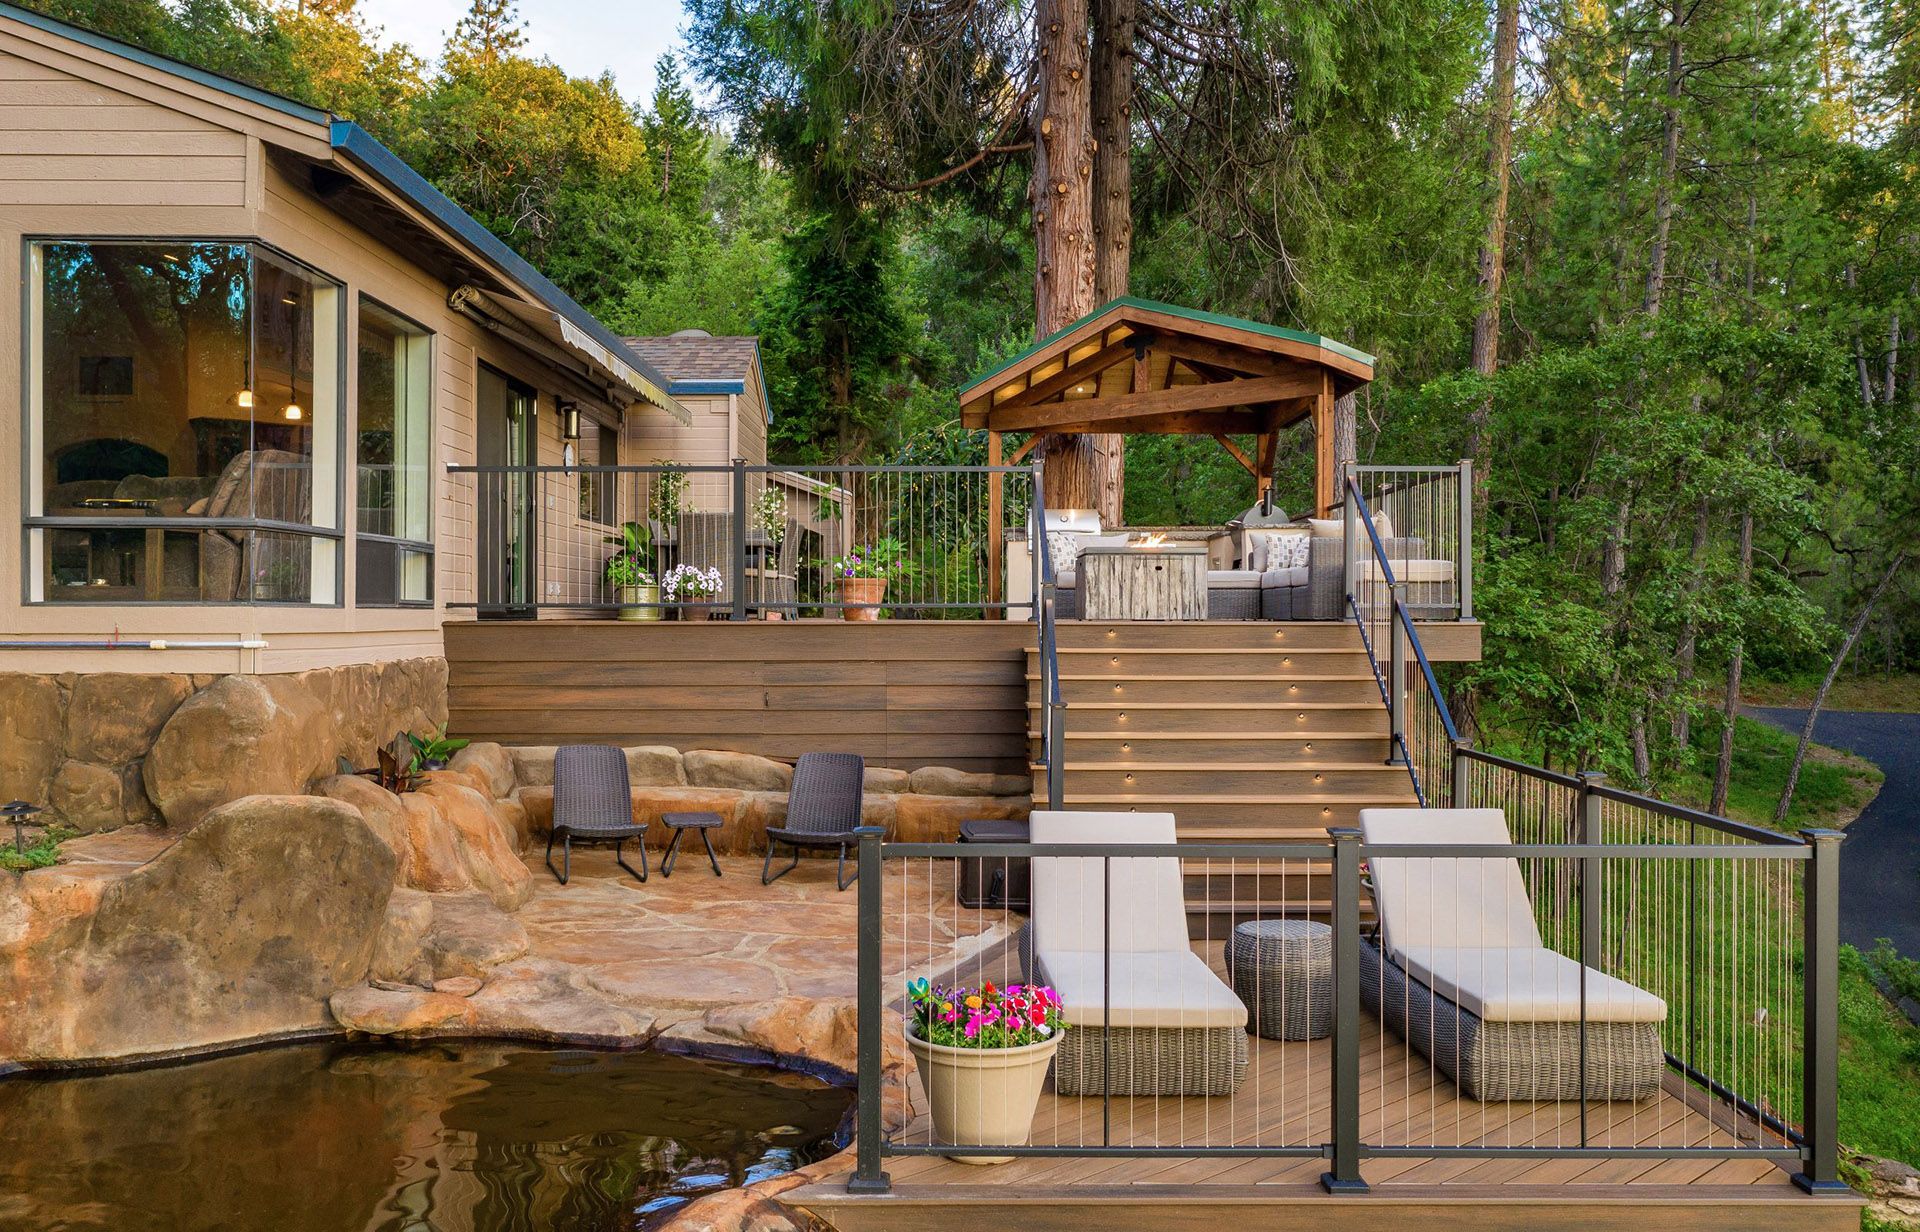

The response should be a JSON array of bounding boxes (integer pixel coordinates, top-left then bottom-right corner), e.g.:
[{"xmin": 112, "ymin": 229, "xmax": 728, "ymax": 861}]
[{"xmin": 19, "ymin": 232, "xmax": 353, "ymax": 612}]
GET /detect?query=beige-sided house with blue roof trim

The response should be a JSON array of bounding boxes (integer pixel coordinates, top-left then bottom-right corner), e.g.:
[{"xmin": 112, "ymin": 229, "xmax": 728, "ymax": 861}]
[{"xmin": 0, "ymin": 4, "xmax": 702, "ymax": 672}]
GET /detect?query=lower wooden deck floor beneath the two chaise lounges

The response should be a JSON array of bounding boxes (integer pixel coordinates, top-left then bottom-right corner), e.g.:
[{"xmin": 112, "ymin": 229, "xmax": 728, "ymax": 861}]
[{"xmin": 781, "ymin": 928, "xmax": 1859, "ymax": 1232}]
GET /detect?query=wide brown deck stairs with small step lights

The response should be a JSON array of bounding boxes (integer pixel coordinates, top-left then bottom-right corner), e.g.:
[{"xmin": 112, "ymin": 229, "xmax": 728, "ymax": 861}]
[{"xmin": 1027, "ymin": 622, "xmax": 1415, "ymax": 924}]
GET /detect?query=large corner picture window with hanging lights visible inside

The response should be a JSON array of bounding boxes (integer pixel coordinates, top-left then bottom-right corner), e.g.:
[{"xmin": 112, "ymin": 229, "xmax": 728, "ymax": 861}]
[{"xmin": 27, "ymin": 240, "xmax": 342, "ymax": 604}]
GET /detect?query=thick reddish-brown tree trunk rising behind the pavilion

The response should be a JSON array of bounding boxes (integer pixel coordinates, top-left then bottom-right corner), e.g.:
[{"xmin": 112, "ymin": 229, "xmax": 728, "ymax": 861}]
[{"xmin": 1033, "ymin": 0, "xmax": 1121, "ymax": 524}]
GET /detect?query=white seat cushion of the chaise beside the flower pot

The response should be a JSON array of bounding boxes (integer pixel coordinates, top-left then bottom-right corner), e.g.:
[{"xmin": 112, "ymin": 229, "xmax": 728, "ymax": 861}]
[{"xmin": 1037, "ymin": 950, "xmax": 1246, "ymax": 1031}]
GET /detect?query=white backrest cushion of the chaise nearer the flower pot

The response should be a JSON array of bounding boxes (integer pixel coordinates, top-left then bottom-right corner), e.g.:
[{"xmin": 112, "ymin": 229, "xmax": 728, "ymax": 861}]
[{"xmin": 1029, "ymin": 808, "xmax": 1188, "ymax": 954}]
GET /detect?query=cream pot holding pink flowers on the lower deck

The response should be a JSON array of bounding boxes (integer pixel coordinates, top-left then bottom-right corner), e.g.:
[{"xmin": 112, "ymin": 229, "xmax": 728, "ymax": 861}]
[{"xmin": 906, "ymin": 1031, "xmax": 1060, "ymax": 1163}]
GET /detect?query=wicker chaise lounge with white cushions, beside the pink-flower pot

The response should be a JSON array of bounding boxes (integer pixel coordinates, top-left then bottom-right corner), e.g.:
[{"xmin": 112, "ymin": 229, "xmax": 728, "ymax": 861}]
[{"xmin": 1025, "ymin": 810, "xmax": 1246, "ymax": 1096}]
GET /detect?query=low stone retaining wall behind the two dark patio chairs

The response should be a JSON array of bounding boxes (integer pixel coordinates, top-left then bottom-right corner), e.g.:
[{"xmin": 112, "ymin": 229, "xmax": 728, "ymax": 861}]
[{"xmin": 507, "ymin": 745, "xmax": 1033, "ymax": 856}]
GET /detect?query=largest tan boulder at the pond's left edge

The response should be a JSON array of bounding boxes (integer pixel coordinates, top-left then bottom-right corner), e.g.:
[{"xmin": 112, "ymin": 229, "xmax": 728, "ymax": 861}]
[{"xmin": 0, "ymin": 796, "xmax": 396, "ymax": 1061}]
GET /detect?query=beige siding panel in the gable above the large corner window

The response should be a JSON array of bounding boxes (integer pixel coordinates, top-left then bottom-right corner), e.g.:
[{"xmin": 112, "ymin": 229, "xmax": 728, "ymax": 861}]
[{"xmin": 0, "ymin": 44, "xmax": 248, "ymax": 205}]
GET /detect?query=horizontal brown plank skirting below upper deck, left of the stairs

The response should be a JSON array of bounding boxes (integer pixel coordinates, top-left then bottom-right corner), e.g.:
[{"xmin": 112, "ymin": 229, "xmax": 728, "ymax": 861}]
[{"xmin": 445, "ymin": 620, "xmax": 1033, "ymax": 773}]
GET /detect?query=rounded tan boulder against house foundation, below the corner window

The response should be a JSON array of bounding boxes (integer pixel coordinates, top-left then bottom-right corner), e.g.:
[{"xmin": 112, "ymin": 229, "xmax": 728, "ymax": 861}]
[{"xmin": 144, "ymin": 675, "xmax": 334, "ymax": 829}]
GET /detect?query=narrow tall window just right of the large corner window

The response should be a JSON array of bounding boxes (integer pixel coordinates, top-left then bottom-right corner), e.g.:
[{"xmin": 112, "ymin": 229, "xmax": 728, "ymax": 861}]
[{"xmin": 353, "ymin": 296, "xmax": 434, "ymax": 606}]
